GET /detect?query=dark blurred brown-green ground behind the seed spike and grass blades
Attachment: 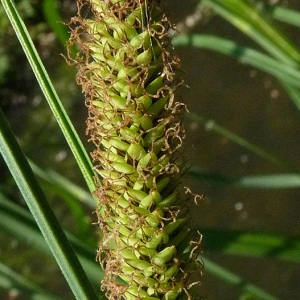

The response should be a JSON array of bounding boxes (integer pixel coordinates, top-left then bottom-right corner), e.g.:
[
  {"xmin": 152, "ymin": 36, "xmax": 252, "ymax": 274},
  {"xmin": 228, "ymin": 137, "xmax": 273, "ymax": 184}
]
[{"xmin": 0, "ymin": 0, "xmax": 300, "ymax": 300}]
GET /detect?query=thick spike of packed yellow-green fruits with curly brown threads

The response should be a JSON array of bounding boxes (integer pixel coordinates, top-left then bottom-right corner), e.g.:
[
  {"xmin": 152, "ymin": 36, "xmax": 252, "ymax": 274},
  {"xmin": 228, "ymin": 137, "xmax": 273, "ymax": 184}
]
[{"xmin": 70, "ymin": 0, "xmax": 199, "ymax": 300}]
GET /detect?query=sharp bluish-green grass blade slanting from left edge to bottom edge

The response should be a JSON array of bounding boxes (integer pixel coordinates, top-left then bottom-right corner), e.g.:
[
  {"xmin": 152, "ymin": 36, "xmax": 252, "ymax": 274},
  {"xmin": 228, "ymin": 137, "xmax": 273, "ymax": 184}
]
[{"xmin": 0, "ymin": 110, "xmax": 96, "ymax": 300}]
